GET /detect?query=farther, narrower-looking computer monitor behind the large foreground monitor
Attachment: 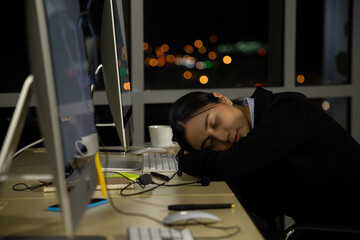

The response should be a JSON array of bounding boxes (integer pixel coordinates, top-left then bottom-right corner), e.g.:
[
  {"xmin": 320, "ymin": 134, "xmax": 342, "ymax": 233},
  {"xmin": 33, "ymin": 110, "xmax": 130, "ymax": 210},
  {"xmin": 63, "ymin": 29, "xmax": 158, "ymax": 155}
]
[{"xmin": 101, "ymin": 0, "xmax": 134, "ymax": 152}]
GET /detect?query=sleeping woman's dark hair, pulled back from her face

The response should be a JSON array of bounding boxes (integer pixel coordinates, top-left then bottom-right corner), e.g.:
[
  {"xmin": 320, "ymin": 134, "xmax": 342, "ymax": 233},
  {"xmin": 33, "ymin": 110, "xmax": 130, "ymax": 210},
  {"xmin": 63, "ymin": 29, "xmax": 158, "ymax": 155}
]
[{"xmin": 169, "ymin": 92, "xmax": 219, "ymax": 151}]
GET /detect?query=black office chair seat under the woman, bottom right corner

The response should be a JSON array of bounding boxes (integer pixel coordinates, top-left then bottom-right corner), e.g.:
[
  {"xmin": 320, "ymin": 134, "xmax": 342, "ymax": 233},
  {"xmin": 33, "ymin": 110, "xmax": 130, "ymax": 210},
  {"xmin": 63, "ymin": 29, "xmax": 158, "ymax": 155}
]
[{"xmin": 284, "ymin": 223, "xmax": 360, "ymax": 240}]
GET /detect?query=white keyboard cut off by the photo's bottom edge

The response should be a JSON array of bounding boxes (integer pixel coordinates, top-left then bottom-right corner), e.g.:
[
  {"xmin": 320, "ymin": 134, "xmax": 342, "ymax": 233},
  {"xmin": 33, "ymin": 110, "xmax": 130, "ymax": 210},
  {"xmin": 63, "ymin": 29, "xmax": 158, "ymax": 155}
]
[{"xmin": 127, "ymin": 227, "xmax": 194, "ymax": 240}]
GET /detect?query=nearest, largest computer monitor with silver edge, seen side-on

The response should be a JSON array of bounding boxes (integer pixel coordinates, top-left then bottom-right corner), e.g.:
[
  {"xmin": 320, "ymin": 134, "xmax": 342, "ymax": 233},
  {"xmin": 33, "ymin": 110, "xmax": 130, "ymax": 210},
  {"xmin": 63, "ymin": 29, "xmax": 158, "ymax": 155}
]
[{"xmin": 26, "ymin": 0, "xmax": 98, "ymax": 237}]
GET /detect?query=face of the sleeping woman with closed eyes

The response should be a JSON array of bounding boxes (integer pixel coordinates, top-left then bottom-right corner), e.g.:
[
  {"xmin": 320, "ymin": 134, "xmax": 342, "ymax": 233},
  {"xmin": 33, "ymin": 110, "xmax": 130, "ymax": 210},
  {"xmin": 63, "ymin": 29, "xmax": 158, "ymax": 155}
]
[{"xmin": 184, "ymin": 93, "xmax": 250, "ymax": 151}]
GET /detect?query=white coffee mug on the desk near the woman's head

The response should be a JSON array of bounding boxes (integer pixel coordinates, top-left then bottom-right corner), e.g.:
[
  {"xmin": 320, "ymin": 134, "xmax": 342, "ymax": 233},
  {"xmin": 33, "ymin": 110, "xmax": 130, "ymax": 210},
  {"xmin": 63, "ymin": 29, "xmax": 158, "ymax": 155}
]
[{"xmin": 149, "ymin": 125, "xmax": 173, "ymax": 147}]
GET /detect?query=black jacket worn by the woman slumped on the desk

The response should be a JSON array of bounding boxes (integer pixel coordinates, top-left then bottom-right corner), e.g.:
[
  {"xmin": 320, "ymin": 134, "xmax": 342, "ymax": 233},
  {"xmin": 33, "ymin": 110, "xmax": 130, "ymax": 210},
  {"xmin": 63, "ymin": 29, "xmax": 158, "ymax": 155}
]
[{"xmin": 179, "ymin": 88, "xmax": 360, "ymax": 224}]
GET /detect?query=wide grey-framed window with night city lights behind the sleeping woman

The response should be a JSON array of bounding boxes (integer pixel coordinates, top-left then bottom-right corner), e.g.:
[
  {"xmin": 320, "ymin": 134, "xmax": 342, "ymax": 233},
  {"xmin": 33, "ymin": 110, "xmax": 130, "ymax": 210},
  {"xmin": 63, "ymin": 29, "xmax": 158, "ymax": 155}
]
[{"xmin": 131, "ymin": 0, "xmax": 360, "ymax": 144}]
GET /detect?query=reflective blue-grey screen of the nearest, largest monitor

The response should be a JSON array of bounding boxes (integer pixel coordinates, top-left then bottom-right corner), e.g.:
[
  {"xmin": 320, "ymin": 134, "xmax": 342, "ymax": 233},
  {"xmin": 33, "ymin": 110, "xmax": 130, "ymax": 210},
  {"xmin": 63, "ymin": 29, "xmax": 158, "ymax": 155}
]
[{"xmin": 45, "ymin": 0, "xmax": 97, "ymax": 167}]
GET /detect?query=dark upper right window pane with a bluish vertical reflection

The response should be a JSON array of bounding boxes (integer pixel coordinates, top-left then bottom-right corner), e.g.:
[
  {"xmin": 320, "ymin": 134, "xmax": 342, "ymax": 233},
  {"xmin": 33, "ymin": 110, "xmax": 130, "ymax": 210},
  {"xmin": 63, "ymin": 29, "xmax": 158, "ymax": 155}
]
[{"xmin": 295, "ymin": 0, "xmax": 352, "ymax": 86}]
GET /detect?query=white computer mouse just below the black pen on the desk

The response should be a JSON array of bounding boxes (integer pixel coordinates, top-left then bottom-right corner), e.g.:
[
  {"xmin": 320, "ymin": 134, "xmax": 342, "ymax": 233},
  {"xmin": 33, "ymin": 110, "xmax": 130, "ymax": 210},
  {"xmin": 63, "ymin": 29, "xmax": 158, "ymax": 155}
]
[{"xmin": 163, "ymin": 211, "xmax": 221, "ymax": 225}]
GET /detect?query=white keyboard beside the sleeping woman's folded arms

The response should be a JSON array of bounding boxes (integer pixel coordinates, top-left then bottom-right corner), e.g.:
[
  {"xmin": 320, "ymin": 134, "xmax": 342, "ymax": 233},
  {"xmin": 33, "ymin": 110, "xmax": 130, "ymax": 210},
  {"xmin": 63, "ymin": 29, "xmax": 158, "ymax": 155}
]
[{"xmin": 143, "ymin": 153, "xmax": 178, "ymax": 173}]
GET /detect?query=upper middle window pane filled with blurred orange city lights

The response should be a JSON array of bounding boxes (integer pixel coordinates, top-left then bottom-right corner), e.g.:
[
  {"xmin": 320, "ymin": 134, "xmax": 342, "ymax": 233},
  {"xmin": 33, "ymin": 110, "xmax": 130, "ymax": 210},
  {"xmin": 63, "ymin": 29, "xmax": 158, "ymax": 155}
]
[{"xmin": 144, "ymin": 0, "xmax": 283, "ymax": 89}]
